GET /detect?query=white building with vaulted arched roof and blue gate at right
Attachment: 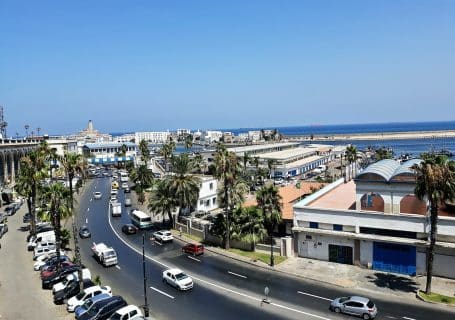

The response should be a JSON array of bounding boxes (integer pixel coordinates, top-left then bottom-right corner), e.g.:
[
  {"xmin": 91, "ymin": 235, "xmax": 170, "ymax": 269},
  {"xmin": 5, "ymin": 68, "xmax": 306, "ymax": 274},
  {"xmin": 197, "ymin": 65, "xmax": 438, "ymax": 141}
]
[{"xmin": 293, "ymin": 160, "xmax": 455, "ymax": 278}]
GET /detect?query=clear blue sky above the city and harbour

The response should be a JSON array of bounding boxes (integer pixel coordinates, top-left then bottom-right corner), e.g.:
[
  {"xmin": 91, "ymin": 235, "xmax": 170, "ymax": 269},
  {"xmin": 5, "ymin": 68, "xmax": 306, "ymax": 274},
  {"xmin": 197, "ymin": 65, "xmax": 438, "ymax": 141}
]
[{"xmin": 0, "ymin": 0, "xmax": 455, "ymax": 135}]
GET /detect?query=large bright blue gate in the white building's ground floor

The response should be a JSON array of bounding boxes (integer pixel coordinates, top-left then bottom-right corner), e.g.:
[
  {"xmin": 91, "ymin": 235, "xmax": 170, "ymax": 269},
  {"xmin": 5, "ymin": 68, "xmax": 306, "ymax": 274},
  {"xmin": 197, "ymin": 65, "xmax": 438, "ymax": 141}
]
[{"xmin": 373, "ymin": 242, "xmax": 416, "ymax": 275}]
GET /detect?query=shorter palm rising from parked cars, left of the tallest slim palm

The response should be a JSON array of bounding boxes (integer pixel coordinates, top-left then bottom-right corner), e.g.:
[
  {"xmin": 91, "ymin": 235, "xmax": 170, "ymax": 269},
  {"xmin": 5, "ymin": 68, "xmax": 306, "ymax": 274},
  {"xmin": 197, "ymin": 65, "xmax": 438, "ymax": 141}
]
[{"xmin": 41, "ymin": 182, "xmax": 71, "ymax": 270}]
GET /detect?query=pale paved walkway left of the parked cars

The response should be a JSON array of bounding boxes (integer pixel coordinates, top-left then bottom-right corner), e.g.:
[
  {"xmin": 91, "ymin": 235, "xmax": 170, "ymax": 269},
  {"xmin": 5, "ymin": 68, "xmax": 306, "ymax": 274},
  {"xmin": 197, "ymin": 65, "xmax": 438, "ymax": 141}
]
[{"xmin": 0, "ymin": 204, "xmax": 74, "ymax": 320}]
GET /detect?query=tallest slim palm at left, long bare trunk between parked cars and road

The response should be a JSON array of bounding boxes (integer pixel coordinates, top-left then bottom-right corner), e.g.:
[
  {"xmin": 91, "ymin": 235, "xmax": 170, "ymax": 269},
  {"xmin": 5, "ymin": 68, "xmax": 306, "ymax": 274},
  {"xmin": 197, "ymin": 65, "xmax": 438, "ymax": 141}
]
[{"xmin": 59, "ymin": 152, "xmax": 87, "ymax": 290}]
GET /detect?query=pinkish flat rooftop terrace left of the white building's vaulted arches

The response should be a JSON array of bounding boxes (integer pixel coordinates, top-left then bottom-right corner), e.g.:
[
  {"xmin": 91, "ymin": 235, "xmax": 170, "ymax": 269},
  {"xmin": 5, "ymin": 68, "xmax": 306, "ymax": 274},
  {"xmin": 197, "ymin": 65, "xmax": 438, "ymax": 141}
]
[{"xmin": 307, "ymin": 180, "xmax": 356, "ymax": 210}]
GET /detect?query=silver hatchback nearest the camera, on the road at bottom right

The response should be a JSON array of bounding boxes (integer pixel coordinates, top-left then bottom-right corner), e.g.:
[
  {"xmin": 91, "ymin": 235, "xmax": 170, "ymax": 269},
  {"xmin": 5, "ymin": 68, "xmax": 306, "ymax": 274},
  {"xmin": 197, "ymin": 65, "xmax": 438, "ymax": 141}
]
[{"xmin": 330, "ymin": 296, "xmax": 378, "ymax": 320}]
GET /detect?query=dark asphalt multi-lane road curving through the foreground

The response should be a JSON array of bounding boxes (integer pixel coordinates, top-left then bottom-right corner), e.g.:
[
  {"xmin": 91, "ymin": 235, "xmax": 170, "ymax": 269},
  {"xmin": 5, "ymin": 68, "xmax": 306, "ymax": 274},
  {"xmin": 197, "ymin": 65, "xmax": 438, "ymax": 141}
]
[{"xmin": 78, "ymin": 178, "xmax": 455, "ymax": 320}]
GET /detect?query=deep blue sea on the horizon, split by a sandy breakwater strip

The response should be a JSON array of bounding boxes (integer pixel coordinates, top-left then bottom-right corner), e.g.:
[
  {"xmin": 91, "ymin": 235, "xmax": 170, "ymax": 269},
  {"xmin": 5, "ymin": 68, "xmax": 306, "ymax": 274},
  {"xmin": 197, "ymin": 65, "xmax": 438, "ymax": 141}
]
[{"xmin": 113, "ymin": 121, "xmax": 455, "ymax": 160}]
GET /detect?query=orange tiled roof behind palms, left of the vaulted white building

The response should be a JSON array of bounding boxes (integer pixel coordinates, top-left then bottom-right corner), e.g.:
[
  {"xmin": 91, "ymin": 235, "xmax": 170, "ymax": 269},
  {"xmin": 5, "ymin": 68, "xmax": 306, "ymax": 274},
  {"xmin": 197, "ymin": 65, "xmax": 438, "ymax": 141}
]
[{"xmin": 243, "ymin": 182, "xmax": 325, "ymax": 220}]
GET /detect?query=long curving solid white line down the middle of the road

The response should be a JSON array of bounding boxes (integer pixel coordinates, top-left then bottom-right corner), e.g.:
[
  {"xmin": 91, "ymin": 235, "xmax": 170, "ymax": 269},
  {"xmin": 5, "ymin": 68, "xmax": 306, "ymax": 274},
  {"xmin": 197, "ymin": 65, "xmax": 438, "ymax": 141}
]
[{"xmin": 107, "ymin": 205, "xmax": 330, "ymax": 320}]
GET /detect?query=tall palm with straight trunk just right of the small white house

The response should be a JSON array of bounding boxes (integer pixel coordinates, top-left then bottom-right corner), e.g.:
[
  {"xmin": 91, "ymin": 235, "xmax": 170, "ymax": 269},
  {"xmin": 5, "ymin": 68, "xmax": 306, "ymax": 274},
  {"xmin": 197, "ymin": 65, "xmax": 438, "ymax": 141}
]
[{"xmin": 215, "ymin": 144, "xmax": 240, "ymax": 250}]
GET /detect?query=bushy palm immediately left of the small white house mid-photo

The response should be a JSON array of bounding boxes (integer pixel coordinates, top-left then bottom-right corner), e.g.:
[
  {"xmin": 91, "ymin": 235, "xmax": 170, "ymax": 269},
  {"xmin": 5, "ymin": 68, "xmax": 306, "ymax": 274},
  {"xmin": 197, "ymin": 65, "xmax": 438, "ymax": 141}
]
[{"xmin": 169, "ymin": 153, "xmax": 201, "ymax": 223}]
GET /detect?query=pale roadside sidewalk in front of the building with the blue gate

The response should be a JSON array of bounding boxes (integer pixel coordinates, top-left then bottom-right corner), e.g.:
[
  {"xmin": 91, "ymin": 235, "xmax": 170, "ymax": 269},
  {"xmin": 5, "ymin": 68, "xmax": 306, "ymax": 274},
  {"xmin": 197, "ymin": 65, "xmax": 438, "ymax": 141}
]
[{"xmin": 173, "ymin": 230, "xmax": 455, "ymax": 303}]
